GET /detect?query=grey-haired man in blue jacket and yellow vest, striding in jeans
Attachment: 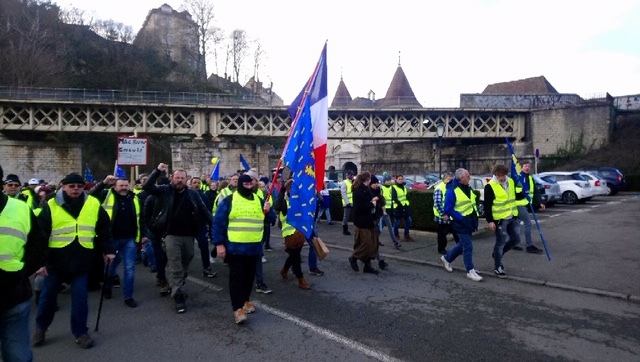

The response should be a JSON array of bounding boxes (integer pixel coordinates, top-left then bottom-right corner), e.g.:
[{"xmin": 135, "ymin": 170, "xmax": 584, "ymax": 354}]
[{"xmin": 440, "ymin": 168, "xmax": 482, "ymax": 282}]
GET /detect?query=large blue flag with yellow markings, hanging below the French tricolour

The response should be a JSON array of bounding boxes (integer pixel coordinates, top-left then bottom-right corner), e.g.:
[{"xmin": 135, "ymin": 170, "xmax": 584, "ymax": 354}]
[{"xmin": 282, "ymin": 98, "xmax": 316, "ymax": 239}]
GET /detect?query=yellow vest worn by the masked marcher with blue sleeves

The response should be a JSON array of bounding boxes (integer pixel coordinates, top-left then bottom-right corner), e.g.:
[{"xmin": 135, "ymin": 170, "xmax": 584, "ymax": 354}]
[{"xmin": 227, "ymin": 192, "xmax": 264, "ymax": 243}]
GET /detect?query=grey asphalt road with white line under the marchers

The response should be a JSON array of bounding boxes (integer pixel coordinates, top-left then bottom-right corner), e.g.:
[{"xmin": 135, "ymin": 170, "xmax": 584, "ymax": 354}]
[{"xmin": 32, "ymin": 194, "xmax": 640, "ymax": 361}]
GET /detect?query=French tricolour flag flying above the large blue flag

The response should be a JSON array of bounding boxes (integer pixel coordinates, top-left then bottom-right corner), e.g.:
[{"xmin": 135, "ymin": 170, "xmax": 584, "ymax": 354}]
[{"xmin": 288, "ymin": 43, "xmax": 329, "ymax": 191}]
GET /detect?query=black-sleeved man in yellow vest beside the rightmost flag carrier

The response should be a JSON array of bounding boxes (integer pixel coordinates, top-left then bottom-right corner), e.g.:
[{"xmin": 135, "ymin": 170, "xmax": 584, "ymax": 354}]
[{"xmin": 484, "ymin": 165, "xmax": 520, "ymax": 278}]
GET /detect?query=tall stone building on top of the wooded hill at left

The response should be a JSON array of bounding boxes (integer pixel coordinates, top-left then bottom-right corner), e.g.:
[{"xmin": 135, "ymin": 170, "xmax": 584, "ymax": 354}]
[{"xmin": 133, "ymin": 3, "xmax": 206, "ymax": 82}]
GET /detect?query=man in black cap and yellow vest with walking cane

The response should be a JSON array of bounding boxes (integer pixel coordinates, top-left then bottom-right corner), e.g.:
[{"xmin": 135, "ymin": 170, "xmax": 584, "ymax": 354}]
[{"xmin": 32, "ymin": 173, "xmax": 115, "ymax": 348}]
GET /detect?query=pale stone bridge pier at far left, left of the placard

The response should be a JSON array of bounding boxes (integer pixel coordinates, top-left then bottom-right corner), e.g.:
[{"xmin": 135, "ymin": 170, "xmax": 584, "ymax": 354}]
[{"xmin": 0, "ymin": 136, "xmax": 83, "ymax": 183}]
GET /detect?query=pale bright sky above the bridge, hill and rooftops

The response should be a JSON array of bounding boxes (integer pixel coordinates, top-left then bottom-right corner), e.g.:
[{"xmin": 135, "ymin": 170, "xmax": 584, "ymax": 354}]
[{"xmin": 52, "ymin": 0, "xmax": 640, "ymax": 108}]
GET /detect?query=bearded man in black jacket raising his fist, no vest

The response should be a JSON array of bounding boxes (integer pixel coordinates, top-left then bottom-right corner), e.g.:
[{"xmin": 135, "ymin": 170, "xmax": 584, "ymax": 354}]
[{"xmin": 143, "ymin": 163, "xmax": 213, "ymax": 313}]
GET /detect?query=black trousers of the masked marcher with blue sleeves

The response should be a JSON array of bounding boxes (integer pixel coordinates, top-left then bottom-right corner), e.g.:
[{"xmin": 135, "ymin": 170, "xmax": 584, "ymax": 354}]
[{"xmin": 225, "ymin": 254, "xmax": 260, "ymax": 311}]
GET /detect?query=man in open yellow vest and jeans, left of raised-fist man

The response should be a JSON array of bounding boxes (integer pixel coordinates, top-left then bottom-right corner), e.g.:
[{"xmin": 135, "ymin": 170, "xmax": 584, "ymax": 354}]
[{"xmin": 90, "ymin": 175, "xmax": 148, "ymax": 308}]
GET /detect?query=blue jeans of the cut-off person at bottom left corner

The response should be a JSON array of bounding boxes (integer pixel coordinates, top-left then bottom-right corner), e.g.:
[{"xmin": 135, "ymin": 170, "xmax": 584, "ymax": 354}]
[{"xmin": 0, "ymin": 299, "xmax": 33, "ymax": 362}]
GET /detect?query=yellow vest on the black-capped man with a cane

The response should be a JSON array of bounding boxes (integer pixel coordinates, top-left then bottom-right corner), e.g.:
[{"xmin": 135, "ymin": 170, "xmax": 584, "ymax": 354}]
[{"xmin": 48, "ymin": 197, "xmax": 100, "ymax": 249}]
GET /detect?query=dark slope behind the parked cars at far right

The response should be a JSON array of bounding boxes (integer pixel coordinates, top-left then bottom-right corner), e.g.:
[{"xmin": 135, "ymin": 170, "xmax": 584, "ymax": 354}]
[{"xmin": 539, "ymin": 114, "xmax": 640, "ymax": 175}]
